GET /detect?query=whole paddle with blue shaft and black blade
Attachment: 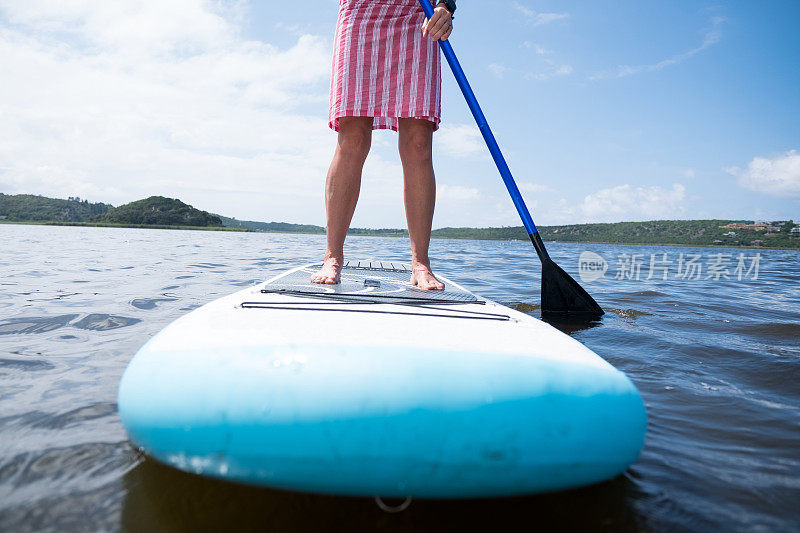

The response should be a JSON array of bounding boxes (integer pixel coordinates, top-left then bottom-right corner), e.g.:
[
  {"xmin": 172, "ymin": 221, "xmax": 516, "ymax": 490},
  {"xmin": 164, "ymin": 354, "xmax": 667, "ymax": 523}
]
[{"xmin": 419, "ymin": 0, "xmax": 603, "ymax": 320}]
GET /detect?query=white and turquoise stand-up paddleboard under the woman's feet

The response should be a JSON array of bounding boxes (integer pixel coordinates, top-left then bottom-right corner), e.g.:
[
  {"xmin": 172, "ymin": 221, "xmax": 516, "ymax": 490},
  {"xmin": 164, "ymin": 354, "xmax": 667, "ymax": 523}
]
[{"xmin": 119, "ymin": 262, "xmax": 647, "ymax": 498}]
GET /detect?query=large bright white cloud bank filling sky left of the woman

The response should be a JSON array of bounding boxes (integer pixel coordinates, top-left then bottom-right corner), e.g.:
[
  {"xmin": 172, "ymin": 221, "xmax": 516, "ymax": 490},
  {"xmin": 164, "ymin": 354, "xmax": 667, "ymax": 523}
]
[{"xmin": 0, "ymin": 0, "xmax": 334, "ymax": 222}]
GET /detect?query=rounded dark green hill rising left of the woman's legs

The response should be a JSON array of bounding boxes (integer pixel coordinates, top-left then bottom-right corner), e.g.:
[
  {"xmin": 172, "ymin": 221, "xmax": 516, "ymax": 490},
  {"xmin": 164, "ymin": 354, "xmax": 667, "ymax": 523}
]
[{"xmin": 90, "ymin": 196, "xmax": 222, "ymax": 227}]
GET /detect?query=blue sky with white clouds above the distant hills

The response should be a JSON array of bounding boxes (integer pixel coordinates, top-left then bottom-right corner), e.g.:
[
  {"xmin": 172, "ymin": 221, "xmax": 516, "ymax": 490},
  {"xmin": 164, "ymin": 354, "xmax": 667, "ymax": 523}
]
[{"xmin": 0, "ymin": 0, "xmax": 800, "ymax": 228}]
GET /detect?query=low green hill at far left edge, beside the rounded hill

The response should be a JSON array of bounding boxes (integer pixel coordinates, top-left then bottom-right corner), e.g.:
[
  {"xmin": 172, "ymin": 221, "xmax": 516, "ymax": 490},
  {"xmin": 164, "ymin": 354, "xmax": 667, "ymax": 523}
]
[{"xmin": 0, "ymin": 193, "xmax": 114, "ymax": 222}]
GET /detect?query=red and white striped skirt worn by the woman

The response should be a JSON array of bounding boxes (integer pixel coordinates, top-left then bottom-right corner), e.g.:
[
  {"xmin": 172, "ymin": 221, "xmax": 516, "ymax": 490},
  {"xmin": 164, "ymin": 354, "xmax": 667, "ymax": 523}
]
[{"xmin": 328, "ymin": 0, "xmax": 442, "ymax": 131}]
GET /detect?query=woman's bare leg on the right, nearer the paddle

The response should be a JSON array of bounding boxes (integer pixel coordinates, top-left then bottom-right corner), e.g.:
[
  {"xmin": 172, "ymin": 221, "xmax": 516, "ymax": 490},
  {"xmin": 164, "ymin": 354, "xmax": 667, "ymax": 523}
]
[{"xmin": 399, "ymin": 118, "xmax": 444, "ymax": 290}]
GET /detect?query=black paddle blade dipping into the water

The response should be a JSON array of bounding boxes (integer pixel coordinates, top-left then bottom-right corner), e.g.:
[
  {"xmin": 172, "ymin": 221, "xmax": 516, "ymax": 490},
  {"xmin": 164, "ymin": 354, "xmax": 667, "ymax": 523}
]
[{"xmin": 530, "ymin": 233, "xmax": 604, "ymax": 321}]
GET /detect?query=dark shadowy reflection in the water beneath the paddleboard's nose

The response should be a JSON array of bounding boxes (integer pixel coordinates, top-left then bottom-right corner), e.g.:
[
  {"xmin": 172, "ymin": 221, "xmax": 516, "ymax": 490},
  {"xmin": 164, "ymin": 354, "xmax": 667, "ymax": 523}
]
[{"xmin": 117, "ymin": 459, "xmax": 645, "ymax": 532}]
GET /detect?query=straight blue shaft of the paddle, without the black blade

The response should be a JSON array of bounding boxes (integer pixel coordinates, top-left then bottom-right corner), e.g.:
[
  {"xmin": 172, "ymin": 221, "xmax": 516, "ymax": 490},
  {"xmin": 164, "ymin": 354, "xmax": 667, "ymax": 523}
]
[{"xmin": 419, "ymin": 0, "xmax": 538, "ymax": 235}]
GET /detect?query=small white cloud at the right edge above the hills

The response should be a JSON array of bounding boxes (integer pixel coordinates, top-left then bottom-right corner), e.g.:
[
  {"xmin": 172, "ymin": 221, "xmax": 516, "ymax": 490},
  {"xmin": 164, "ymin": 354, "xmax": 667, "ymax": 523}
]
[{"xmin": 726, "ymin": 150, "xmax": 800, "ymax": 197}]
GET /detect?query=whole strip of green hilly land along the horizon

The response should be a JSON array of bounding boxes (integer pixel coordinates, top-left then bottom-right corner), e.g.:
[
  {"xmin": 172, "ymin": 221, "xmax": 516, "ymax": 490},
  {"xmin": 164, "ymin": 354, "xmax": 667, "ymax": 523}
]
[{"xmin": 0, "ymin": 193, "xmax": 800, "ymax": 250}]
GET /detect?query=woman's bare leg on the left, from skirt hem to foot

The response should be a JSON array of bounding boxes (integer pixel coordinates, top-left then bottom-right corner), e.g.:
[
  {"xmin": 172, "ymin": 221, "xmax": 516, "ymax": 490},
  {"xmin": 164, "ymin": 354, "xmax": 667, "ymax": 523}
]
[{"xmin": 311, "ymin": 117, "xmax": 372, "ymax": 283}]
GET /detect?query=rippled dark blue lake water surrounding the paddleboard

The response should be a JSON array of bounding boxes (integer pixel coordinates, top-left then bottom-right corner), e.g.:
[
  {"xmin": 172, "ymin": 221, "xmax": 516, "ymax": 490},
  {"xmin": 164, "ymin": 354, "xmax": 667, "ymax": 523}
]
[{"xmin": 0, "ymin": 225, "xmax": 800, "ymax": 531}]
